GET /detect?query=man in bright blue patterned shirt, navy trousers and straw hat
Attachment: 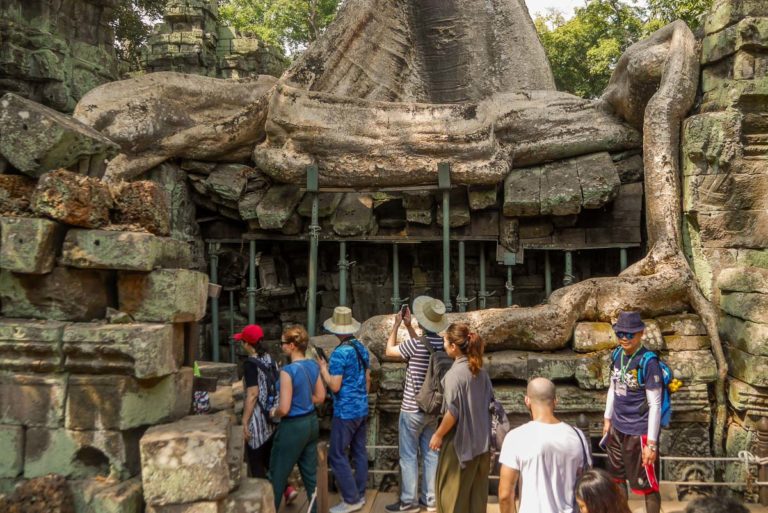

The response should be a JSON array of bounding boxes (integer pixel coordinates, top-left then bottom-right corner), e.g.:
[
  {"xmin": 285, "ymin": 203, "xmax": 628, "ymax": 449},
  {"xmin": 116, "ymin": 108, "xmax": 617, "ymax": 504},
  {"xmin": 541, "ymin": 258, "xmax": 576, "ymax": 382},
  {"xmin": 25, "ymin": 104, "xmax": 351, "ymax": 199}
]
[{"xmin": 318, "ymin": 306, "xmax": 371, "ymax": 513}]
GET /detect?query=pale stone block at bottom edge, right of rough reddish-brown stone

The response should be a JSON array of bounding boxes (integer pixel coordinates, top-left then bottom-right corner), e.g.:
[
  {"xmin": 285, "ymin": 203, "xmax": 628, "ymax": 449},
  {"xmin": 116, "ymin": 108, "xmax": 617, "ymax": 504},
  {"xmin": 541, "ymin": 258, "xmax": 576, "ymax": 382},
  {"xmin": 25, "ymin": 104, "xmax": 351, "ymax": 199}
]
[{"xmin": 69, "ymin": 477, "xmax": 144, "ymax": 513}]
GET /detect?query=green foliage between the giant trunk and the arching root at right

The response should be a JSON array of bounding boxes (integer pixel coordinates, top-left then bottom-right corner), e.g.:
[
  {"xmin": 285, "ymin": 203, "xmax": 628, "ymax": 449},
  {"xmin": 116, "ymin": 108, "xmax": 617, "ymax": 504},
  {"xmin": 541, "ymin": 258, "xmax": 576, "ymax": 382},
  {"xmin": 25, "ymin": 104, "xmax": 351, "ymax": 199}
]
[{"xmin": 534, "ymin": 0, "xmax": 712, "ymax": 98}]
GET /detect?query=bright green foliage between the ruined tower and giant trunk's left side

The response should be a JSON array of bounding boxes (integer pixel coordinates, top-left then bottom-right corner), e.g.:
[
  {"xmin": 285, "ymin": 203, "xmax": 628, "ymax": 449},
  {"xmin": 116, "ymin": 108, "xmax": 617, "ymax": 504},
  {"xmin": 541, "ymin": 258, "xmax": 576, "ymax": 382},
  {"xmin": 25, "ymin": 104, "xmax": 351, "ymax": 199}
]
[{"xmin": 219, "ymin": 0, "xmax": 339, "ymax": 54}]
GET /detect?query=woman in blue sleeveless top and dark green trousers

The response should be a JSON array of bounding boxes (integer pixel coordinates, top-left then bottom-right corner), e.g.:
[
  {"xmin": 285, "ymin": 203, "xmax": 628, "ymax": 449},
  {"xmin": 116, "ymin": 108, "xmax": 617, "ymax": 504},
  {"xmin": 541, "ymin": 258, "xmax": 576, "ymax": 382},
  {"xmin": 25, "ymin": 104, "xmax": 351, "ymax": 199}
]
[{"xmin": 270, "ymin": 326, "xmax": 325, "ymax": 511}]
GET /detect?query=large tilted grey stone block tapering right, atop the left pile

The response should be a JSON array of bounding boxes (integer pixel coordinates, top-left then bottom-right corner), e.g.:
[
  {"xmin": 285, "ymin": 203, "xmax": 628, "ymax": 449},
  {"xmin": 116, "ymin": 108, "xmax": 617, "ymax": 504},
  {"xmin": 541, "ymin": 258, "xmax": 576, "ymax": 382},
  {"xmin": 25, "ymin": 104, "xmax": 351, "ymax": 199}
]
[{"xmin": 0, "ymin": 93, "xmax": 119, "ymax": 178}]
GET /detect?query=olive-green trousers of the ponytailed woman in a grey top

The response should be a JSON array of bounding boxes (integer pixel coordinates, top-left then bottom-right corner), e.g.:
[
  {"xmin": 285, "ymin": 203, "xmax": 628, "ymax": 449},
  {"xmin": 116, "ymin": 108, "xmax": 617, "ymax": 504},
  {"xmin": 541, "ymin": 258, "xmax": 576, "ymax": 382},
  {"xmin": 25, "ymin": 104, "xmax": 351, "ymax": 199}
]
[{"xmin": 435, "ymin": 429, "xmax": 491, "ymax": 513}]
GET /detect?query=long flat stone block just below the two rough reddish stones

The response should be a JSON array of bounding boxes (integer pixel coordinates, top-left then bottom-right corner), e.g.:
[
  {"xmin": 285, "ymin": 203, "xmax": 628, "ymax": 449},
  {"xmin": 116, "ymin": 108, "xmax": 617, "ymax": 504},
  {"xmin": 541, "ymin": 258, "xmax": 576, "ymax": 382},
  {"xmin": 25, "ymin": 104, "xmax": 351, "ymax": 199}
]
[{"xmin": 60, "ymin": 229, "xmax": 192, "ymax": 271}]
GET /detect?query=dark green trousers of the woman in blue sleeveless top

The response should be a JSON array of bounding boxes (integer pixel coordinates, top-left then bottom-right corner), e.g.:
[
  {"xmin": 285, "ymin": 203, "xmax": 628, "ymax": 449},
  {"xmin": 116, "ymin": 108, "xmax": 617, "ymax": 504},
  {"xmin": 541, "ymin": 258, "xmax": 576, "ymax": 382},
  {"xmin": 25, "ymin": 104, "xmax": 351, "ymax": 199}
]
[{"xmin": 269, "ymin": 413, "xmax": 320, "ymax": 513}]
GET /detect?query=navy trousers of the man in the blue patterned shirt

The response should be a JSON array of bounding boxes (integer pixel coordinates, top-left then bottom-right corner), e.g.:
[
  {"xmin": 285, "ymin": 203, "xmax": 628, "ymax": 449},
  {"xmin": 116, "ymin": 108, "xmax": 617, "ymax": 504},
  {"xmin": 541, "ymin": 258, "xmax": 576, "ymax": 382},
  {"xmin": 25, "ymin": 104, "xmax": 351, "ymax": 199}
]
[{"xmin": 328, "ymin": 417, "xmax": 368, "ymax": 504}]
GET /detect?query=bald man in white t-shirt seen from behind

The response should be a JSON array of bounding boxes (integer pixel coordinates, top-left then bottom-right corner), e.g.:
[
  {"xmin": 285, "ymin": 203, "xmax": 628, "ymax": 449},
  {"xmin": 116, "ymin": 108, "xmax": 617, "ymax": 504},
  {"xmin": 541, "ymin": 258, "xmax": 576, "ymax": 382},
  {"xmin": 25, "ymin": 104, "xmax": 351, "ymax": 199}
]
[{"xmin": 499, "ymin": 378, "xmax": 592, "ymax": 513}]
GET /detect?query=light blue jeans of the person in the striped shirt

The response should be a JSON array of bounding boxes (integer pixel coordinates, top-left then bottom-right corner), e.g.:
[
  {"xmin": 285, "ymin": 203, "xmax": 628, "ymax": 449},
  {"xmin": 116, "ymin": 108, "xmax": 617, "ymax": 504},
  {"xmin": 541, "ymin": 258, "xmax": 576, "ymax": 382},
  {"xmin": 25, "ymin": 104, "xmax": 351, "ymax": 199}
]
[{"xmin": 399, "ymin": 411, "xmax": 438, "ymax": 506}]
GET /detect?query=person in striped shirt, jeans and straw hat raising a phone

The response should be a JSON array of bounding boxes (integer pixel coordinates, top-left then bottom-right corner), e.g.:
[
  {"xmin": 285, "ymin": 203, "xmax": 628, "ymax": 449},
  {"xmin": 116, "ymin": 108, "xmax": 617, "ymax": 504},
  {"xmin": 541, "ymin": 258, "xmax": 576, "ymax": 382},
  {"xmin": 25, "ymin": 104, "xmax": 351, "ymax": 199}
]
[{"xmin": 385, "ymin": 296, "xmax": 448, "ymax": 512}]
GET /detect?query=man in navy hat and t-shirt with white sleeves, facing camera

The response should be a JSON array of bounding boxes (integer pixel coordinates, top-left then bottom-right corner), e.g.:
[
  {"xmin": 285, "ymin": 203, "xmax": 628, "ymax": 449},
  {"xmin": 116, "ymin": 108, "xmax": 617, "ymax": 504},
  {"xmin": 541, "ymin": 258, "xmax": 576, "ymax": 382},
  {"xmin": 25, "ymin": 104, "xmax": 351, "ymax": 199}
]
[{"xmin": 603, "ymin": 312, "xmax": 664, "ymax": 513}]
